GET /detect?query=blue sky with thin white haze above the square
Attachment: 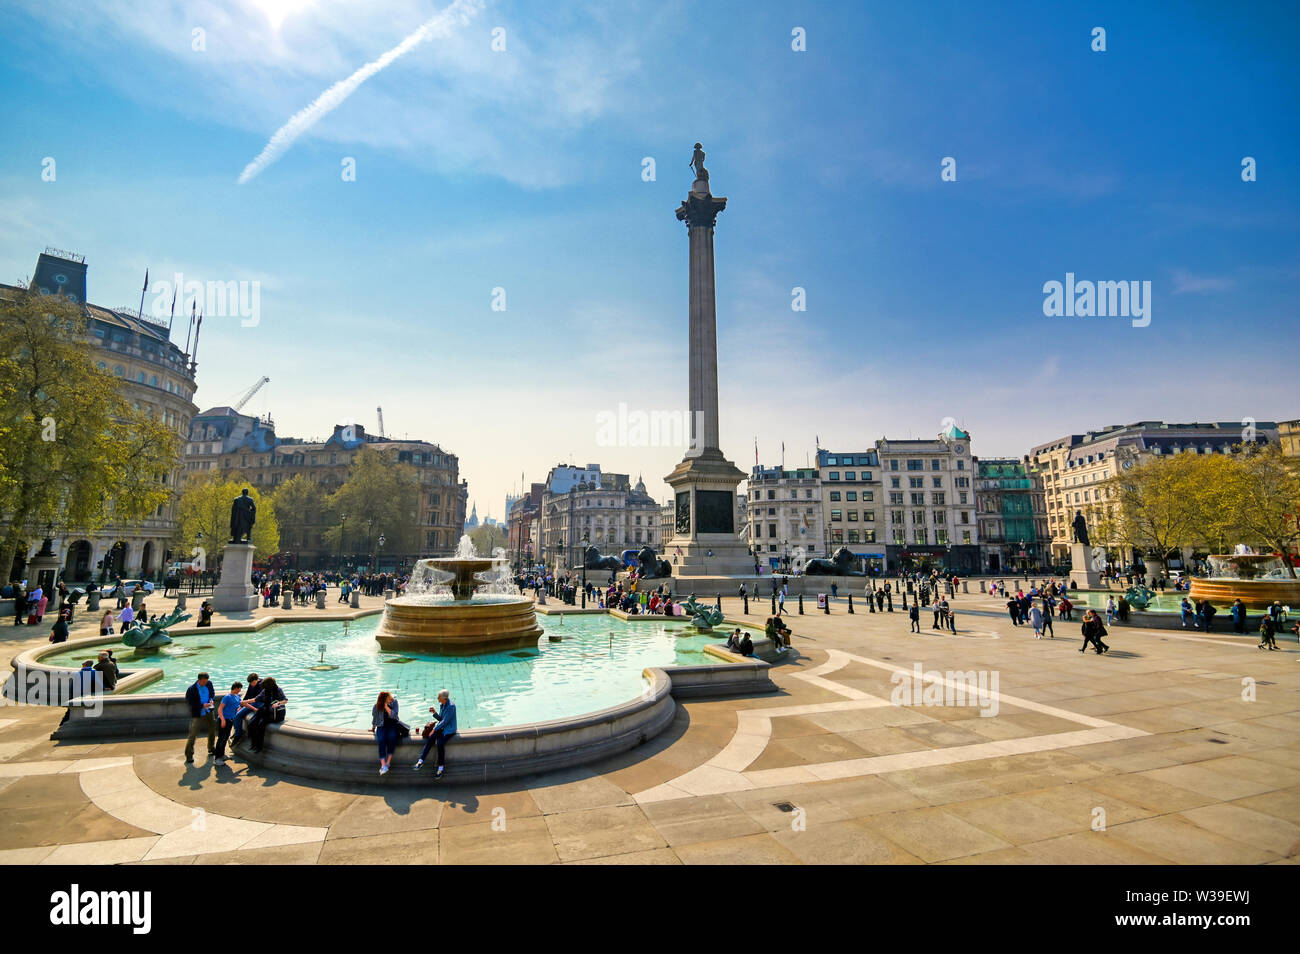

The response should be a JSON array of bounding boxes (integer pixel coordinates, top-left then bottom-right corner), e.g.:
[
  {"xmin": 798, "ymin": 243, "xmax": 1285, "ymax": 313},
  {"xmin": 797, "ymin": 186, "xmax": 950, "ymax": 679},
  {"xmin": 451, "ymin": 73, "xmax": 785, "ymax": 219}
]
[{"xmin": 0, "ymin": 0, "xmax": 1300, "ymax": 516}]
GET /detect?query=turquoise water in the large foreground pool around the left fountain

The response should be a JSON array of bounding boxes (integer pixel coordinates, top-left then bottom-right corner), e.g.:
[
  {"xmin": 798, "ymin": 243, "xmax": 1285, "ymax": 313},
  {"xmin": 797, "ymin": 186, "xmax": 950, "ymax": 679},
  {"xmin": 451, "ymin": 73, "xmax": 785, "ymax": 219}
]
[{"xmin": 42, "ymin": 613, "xmax": 725, "ymax": 729}]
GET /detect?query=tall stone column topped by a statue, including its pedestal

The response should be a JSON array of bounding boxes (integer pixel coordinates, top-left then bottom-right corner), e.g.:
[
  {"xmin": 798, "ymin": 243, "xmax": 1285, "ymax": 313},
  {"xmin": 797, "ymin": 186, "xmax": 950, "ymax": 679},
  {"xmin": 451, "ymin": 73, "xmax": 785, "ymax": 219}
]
[{"xmin": 664, "ymin": 143, "xmax": 754, "ymax": 578}]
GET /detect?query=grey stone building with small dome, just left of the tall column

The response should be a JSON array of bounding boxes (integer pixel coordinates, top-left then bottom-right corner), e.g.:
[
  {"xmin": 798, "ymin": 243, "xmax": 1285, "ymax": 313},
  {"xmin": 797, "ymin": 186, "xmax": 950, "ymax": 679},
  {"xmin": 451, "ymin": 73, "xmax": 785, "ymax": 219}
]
[{"xmin": 540, "ymin": 464, "xmax": 662, "ymax": 571}]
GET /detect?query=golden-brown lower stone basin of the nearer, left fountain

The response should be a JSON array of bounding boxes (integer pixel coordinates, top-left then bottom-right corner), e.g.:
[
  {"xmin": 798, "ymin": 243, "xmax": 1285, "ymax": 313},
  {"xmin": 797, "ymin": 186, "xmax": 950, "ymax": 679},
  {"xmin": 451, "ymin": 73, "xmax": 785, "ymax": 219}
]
[{"xmin": 374, "ymin": 597, "xmax": 542, "ymax": 655}]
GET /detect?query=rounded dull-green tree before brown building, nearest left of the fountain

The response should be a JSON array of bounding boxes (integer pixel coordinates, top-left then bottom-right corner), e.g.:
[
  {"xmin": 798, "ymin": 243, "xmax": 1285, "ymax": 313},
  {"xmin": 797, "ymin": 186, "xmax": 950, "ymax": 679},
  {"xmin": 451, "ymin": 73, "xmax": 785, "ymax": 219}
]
[{"xmin": 324, "ymin": 447, "xmax": 420, "ymax": 563}]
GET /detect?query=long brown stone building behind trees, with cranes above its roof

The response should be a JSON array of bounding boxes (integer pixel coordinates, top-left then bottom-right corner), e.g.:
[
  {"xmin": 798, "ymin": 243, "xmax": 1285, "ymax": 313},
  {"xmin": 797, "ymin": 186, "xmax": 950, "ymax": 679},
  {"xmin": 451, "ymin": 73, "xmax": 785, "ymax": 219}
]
[{"xmin": 185, "ymin": 407, "xmax": 469, "ymax": 569}]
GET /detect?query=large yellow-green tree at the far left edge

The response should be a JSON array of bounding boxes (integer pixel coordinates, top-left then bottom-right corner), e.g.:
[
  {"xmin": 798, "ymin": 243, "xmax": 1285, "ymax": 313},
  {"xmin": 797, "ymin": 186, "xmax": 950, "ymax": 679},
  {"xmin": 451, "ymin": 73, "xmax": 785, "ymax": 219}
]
[{"xmin": 0, "ymin": 289, "xmax": 179, "ymax": 582}]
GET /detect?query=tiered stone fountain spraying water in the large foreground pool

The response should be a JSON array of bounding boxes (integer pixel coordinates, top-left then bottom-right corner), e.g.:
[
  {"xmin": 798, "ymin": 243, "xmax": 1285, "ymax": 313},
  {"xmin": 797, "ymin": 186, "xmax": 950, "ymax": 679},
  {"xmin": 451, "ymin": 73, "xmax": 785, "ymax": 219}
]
[{"xmin": 374, "ymin": 537, "xmax": 542, "ymax": 655}]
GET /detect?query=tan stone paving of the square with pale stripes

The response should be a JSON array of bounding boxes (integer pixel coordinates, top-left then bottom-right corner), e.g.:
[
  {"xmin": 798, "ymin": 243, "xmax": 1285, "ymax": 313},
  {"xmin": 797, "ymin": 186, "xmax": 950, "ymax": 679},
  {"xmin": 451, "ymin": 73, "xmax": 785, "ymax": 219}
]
[{"xmin": 0, "ymin": 594, "xmax": 1300, "ymax": 864}]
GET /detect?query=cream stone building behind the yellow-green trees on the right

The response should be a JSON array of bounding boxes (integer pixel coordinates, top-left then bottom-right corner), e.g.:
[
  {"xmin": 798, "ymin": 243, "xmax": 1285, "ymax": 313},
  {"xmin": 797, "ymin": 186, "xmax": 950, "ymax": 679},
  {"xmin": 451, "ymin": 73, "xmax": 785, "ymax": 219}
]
[{"xmin": 1028, "ymin": 421, "xmax": 1279, "ymax": 569}]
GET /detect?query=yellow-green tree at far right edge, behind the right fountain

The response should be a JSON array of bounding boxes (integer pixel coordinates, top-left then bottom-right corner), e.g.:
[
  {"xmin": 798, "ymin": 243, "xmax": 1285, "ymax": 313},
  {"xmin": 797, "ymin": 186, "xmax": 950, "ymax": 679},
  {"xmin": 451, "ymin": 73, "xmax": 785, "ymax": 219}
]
[{"xmin": 1221, "ymin": 445, "xmax": 1300, "ymax": 578}]
